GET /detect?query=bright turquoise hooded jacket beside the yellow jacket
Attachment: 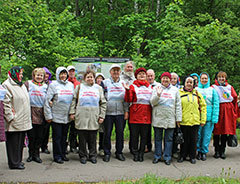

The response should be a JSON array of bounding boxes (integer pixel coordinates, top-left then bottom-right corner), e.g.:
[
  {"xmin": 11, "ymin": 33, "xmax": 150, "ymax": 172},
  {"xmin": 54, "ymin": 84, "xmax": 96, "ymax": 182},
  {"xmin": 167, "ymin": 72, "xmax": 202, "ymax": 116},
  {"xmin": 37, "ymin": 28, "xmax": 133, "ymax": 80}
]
[{"xmin": 197, "ymin": 72, "xmax": 219, "ymax": 123}]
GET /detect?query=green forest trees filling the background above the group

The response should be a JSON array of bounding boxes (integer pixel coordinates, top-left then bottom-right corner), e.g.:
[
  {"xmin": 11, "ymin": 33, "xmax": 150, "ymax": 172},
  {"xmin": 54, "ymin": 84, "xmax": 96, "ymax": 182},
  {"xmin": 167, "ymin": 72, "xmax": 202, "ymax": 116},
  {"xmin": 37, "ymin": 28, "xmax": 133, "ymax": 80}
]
[{"xmin": 0, "ymin": 0, "xmax": 240, "ymax": 91}]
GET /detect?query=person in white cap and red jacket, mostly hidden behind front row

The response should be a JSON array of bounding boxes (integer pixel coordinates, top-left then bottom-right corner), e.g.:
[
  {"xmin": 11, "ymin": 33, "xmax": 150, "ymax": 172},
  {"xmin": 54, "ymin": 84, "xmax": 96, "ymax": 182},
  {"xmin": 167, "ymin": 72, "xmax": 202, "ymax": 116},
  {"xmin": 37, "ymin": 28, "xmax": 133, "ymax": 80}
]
[{"xmin": 67, "ymin": 65, "xmax": 80, "ymax": 153}]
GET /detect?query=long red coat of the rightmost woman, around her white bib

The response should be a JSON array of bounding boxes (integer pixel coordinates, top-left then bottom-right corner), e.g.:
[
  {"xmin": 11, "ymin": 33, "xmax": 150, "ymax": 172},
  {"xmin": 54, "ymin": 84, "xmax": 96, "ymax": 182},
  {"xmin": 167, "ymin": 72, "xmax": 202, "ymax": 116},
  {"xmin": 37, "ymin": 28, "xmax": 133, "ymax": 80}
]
[{"xmin": 213, "ymin": 81, "xmax": 239, "ymax": 135}]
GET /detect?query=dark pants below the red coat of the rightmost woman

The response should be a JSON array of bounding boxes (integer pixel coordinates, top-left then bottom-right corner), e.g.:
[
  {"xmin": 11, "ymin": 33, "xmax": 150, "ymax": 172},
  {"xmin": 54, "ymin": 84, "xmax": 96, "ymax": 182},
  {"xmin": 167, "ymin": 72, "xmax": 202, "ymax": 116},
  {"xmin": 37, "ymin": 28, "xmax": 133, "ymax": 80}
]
[{"xmin": 213, "ymin": 134, "xmax": 227, "ymax": 153}]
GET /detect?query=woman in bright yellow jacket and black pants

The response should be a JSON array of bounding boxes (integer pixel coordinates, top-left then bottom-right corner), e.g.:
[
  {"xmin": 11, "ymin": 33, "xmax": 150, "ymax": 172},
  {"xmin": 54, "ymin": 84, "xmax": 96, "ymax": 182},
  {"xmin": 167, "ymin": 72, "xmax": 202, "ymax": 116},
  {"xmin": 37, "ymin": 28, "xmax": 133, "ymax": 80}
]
[{"xmin": 178, "ymin": 76, "xmax": 207, "ymax": 164}]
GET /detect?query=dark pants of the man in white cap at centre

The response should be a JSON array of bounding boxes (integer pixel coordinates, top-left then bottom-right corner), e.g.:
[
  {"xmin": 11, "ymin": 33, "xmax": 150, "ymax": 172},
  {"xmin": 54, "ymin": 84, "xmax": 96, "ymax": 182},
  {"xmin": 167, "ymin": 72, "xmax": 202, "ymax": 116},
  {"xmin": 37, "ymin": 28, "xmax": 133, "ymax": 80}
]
[{"xmin": 104, "ymin": 115, "xmax": 126, "ymax": 155}]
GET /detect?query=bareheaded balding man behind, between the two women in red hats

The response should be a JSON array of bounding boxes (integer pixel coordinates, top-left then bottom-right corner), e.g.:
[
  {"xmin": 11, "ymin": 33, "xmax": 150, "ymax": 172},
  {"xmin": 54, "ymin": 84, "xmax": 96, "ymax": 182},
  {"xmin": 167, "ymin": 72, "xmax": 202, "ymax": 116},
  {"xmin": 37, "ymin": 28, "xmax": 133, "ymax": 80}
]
[{"xmin": 145, "ymin": 69, "xmax": 159, "ymax": 153}]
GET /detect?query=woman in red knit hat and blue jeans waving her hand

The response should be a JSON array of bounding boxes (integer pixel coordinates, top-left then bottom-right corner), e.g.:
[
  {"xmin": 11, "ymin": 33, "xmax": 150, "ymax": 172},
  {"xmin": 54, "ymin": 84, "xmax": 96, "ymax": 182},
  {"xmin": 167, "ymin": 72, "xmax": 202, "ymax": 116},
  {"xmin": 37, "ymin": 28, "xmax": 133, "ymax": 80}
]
[{"xmin": 151, "ymin": 72, "xmax": 182, "ymax": 165}]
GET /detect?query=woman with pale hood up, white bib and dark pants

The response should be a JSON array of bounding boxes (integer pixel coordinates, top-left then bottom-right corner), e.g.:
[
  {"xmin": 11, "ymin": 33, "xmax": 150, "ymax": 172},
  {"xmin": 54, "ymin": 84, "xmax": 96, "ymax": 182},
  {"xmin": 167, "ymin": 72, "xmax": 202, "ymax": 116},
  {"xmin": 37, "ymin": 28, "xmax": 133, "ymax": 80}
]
[{"xmin": 44, "ymin": 67, "xmax": 74, "ymax": 164}]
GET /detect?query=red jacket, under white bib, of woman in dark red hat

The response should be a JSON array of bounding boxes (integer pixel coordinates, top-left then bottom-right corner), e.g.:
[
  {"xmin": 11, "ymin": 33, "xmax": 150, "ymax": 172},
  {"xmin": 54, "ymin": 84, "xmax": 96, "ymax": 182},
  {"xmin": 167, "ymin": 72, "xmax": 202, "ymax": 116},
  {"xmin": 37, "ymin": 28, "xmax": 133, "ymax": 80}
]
[{"xmin": 125, "ymin": 80, "xmax": 152, "ymax": 124}]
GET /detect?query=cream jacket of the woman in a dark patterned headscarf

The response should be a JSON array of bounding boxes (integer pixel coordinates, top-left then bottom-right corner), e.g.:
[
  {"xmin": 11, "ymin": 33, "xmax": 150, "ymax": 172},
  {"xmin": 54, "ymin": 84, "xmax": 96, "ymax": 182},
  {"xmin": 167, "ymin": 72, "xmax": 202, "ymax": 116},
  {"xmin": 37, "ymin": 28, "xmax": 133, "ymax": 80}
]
[{"xmin": 2, "ymin": 77, "xmax": 32, "ymax": 132}]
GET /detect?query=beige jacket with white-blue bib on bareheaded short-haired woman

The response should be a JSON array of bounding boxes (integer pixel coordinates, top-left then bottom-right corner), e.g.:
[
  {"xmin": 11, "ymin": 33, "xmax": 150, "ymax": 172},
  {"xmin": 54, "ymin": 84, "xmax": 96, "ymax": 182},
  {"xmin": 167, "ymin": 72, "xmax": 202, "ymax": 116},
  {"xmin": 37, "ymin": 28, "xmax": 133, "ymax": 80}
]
[{"xmin": 69, "ymin": 82, "xmax": 107, "ymax": 130}]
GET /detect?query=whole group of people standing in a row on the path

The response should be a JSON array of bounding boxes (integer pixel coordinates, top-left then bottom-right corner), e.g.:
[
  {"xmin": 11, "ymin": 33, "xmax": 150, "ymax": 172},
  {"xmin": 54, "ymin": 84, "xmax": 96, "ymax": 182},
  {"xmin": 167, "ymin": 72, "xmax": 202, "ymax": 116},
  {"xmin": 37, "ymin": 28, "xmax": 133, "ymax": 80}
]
[{"xmin": 0, "ymin": 61, "xmax": 239, "ymax": 169}]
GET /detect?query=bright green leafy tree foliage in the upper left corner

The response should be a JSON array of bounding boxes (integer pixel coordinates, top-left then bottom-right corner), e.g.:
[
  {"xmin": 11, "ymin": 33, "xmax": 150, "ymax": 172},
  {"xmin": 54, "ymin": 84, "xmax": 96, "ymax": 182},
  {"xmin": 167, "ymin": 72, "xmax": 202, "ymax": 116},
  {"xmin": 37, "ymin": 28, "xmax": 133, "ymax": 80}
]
[{"xmin": 0, "ymin": 0, "xmax": 97, "ymax": 82}]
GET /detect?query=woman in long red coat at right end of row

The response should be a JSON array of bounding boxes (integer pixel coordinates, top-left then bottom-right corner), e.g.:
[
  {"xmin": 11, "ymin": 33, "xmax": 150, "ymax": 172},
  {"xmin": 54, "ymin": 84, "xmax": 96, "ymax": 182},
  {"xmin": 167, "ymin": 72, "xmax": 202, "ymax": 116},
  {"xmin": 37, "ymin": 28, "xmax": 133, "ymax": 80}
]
[{"xmin": 213, "ymin": 71, "xmax": 238, "ymax": 159}]
